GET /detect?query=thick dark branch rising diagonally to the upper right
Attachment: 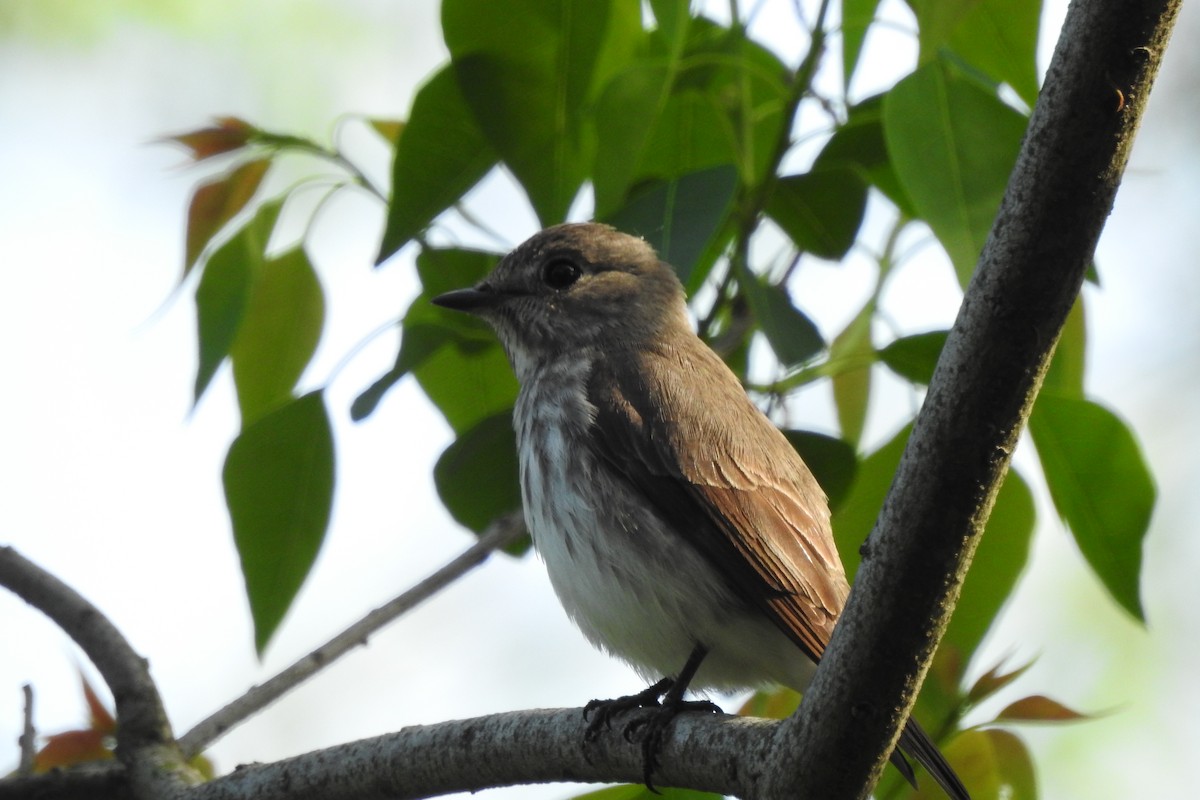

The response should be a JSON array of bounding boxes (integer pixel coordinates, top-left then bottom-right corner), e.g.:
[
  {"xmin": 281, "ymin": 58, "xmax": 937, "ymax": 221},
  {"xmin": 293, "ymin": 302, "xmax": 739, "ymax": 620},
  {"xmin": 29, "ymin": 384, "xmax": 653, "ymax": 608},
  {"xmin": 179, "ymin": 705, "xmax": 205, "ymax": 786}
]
[{"xmin": 763, "ymin": 0, "xmax": 1180, "ymax": 799}]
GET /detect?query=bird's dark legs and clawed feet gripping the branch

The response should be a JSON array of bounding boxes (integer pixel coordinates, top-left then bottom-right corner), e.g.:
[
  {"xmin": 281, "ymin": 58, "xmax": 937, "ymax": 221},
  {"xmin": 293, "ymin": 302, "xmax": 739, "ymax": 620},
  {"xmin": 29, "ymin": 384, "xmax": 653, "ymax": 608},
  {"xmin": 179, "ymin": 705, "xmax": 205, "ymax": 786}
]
[{"xmin": 583, "ymin": 644, "xmax": 721, "ymax": 792}]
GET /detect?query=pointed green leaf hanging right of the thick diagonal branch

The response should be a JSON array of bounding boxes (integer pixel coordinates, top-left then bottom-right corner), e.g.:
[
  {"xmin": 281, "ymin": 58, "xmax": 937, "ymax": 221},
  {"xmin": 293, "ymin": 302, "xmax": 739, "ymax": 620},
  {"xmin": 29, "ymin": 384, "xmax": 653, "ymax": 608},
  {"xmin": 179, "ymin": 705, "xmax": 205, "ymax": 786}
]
[{"xmin": 1030, "ymin": 391, "xmax": 1156, "ymax": 621}]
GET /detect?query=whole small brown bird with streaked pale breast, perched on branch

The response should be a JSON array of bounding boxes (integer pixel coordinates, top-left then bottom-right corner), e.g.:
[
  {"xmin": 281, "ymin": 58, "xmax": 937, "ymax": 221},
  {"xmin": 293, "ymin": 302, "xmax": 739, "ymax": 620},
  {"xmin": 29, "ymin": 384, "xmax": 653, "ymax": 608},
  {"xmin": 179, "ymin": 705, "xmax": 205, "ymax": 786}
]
[{"xmin": 433, "ymin": 223, "xmax": 968, "ymax": 799}]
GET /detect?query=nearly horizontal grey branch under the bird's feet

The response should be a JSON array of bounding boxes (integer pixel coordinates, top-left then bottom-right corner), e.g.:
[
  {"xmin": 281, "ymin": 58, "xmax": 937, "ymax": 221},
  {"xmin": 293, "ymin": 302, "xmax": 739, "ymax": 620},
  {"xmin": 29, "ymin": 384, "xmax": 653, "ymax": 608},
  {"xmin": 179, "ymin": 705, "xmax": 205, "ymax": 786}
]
[{"xmin": 188, "ymin": 709, "xmax": 779, "ymax": 800}]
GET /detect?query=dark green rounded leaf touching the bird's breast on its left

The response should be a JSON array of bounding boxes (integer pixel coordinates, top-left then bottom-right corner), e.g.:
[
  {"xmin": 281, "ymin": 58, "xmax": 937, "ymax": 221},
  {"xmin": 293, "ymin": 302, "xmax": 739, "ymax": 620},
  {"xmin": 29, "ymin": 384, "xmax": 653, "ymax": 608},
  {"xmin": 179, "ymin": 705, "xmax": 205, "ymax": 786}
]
[{"xmin": 433, "ymin": 409, "xmax": 521, "ymax": 534}]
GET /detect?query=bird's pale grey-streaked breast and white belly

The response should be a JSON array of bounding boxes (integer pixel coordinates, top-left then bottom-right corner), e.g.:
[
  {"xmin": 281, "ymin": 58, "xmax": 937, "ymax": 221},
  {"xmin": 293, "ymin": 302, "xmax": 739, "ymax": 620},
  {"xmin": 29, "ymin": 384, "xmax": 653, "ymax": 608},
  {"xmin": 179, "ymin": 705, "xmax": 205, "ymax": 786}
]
[{"xmin": 517, "ymin": 367, "xmax": 812, "ymax": 688}]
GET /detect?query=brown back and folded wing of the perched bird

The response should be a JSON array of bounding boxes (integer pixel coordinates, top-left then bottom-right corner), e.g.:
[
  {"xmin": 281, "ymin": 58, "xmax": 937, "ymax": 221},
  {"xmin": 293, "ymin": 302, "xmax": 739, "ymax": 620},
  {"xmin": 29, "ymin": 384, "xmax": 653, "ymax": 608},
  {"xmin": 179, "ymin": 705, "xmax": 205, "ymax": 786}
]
[{"xmin": 588, "ymin": 336, "xmax": 850, "ymax": 660}]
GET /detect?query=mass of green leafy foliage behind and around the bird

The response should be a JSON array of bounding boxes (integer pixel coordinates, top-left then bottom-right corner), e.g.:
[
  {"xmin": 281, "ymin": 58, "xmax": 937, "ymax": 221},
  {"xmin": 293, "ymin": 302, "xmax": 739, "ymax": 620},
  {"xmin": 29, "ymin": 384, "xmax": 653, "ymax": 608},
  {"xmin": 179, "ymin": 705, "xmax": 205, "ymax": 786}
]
[{"xmin": 173, "ymin": 0, "xmax": 1154, "ymax": 798}]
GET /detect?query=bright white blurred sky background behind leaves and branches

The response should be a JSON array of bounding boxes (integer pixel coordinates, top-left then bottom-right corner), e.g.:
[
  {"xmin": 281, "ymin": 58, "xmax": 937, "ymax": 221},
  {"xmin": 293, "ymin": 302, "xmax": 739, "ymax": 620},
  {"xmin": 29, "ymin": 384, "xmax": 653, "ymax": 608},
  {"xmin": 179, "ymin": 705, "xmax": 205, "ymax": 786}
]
[{"xmin": 0, "ymin": 0, "xmax": 1200, "ymax": 799}]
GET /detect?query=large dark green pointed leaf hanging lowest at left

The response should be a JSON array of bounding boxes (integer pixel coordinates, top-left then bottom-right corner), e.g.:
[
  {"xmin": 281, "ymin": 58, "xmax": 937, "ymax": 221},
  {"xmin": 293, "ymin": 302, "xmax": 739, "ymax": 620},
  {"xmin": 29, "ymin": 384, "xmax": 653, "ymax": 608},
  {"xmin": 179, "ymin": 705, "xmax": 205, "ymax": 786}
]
[{"xmin": 222, "ymin": 392, "xmax": 334, "ymax": 655}]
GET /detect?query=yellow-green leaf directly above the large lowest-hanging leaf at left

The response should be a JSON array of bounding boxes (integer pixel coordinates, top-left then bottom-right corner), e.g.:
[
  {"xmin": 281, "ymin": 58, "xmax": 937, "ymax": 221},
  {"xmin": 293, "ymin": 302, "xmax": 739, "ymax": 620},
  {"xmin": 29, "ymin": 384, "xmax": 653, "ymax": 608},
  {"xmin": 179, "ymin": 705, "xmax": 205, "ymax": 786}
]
[{"xmin": 229, "ymin": 247, "xmax": 325, "ymax": 427}]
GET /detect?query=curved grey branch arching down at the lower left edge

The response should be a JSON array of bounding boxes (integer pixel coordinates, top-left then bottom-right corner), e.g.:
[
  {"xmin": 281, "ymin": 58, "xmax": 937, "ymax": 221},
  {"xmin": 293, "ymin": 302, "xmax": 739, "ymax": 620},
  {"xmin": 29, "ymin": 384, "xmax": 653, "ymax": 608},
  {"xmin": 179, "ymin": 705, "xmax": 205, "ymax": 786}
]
[{"xmin": 0, "ymin": 547, "xmax": 192, "ymax": 798}]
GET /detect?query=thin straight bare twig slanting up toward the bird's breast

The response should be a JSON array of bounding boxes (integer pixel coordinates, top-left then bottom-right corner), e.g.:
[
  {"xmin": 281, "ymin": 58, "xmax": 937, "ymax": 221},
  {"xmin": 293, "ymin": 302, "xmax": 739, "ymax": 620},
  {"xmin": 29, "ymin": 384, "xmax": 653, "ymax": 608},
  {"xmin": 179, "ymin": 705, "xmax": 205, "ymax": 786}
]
[{"xmin": 179, "ymin": 513, "xmax": 524, "ymax": 758}]
